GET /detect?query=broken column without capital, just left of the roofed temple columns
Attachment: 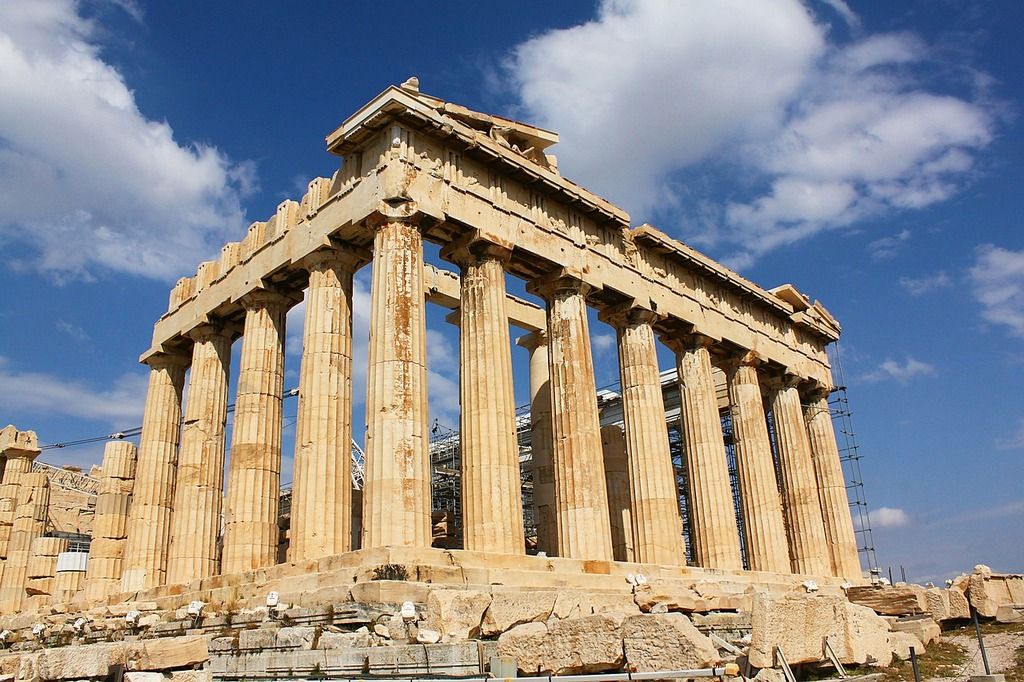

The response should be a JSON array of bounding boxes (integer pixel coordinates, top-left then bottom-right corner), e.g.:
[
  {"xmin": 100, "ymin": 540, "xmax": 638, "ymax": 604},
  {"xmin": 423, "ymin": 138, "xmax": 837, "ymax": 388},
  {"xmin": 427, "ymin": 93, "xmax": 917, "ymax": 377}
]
[{"xmin": 85, "ymin": 440, "xmax": 137, "ymax": 603}]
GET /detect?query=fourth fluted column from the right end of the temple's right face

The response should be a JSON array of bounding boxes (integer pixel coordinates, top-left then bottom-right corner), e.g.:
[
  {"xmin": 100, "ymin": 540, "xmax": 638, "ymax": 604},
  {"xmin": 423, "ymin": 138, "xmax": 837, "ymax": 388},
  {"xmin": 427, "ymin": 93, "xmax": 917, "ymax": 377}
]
[{"xmin": 669, "ymin": 334, "xmax": 743, "ymax": 570}]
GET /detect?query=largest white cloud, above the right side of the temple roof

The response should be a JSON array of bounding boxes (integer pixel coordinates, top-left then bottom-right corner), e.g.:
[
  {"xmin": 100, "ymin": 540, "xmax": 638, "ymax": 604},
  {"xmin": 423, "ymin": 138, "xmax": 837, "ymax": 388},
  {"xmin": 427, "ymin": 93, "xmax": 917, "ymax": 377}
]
[{"xmin": 509, "ymin": 0, "xmax": 994, "ymax": 266}]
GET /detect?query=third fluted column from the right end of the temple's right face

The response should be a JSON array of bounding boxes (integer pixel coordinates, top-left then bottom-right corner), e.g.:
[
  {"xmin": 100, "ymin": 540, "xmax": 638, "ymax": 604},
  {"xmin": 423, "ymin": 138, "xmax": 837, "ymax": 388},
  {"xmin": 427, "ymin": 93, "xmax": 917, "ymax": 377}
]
[{"xmin": 725, "ymin": 353, "xmax": 791, "ymax": 573}]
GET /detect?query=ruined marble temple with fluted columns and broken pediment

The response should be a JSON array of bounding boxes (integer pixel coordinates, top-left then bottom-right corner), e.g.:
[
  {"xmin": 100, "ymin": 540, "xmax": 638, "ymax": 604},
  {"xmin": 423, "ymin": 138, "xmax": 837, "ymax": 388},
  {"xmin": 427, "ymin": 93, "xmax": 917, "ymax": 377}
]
[{"xmin": 0, "ymin": 79, "xmax": 860, "ymax": 598}]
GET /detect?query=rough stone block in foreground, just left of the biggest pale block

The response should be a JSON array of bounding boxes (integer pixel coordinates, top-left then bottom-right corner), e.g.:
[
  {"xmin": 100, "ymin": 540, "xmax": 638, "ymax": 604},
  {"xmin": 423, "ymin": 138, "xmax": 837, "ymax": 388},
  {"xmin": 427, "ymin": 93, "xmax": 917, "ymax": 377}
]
[{"xmin": 623, "ymin": 613, "xmax": 719, "ymax": 673}]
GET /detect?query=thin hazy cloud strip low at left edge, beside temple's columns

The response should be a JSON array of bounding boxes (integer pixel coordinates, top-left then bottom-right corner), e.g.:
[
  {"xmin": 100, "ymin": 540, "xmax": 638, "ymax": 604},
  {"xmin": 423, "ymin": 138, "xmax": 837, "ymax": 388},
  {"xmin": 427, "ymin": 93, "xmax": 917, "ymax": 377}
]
[{"xmin": 0, "ymin": 356, "xmax": 147, "ymax": 428}]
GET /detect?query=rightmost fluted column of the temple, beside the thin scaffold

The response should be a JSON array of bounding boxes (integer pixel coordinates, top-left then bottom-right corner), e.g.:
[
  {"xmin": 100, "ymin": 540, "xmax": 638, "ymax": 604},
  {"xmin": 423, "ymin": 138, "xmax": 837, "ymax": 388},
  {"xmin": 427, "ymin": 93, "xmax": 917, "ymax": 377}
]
[{"xmin": 804, "ymin": 388, "xmax": 861, "ymax": 578}]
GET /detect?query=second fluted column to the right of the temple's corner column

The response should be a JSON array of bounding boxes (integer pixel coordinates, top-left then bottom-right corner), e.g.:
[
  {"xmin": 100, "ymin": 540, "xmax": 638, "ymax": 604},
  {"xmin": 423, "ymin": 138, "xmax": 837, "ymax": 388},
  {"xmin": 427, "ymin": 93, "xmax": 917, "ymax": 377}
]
[{"xmin": 531, "ymin": 276, "xmax": 612, "ymax": 560}]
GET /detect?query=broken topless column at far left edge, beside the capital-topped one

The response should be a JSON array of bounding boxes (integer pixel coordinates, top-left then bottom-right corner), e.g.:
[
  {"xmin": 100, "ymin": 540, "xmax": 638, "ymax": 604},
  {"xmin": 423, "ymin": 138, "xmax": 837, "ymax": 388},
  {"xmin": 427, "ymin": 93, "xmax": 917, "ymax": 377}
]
[{"xmin": 0, "ymin": 472, "xmax": 50, "ymax": 613}]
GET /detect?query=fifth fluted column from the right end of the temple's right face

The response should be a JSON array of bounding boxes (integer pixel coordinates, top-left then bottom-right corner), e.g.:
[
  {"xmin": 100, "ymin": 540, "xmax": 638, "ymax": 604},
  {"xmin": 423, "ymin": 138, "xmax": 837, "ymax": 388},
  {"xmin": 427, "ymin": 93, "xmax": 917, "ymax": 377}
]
[{"xmin": 607, "ymin": 308, "xmax": 686, "ymax": 565}]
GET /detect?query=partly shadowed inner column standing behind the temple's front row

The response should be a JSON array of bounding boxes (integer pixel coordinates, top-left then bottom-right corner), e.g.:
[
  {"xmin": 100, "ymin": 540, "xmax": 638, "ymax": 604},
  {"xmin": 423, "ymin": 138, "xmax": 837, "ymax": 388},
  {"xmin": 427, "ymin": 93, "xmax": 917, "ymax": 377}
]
[{"xmin": 516, "ymin": 330, "xmax": 558, "ymax": 556}]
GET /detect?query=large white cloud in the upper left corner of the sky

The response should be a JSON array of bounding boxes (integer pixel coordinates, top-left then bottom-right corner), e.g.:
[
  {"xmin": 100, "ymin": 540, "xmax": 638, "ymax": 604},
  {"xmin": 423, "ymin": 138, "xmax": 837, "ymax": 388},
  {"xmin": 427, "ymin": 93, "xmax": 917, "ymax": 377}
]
[{"xmin": 0, "ymin": 0, "xmax": 253, "ymax": 279}]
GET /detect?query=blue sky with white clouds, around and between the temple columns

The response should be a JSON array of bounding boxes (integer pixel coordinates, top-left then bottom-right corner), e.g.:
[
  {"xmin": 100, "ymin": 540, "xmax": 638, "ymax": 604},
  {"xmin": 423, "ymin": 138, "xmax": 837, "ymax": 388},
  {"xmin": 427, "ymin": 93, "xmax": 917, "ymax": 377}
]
[{"xmin": 0, "ymin": 0, "xmax": 1024, "ymax": 581}]
